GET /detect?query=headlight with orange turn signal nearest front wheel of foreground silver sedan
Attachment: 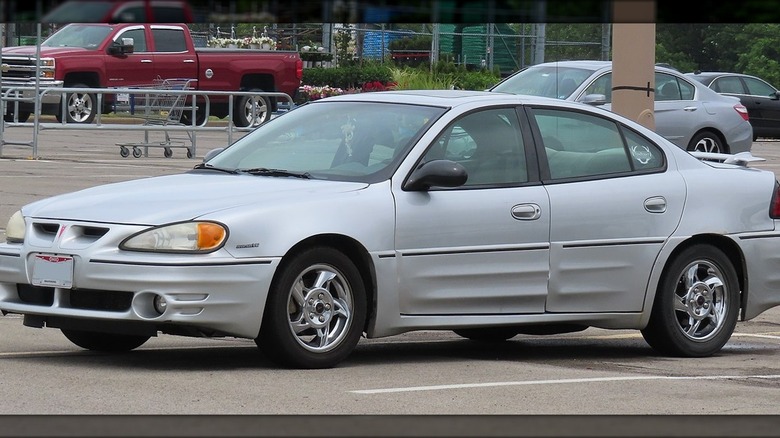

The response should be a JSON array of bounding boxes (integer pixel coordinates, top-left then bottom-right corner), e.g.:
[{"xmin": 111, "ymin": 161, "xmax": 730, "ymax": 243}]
[{"xmin": 119, "ymin": 222, "xmax": 228, "ymax": 253}]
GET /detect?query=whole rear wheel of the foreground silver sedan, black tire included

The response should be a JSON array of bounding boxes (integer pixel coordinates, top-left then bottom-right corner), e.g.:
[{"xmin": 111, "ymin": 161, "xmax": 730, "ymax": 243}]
[{"xmin": 642, "ymin": 245, "xmax": 740, "ymax": 357}]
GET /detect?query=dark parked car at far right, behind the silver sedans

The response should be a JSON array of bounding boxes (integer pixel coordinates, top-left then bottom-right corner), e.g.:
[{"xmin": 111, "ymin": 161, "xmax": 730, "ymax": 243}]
[{"xmin": 685, "ymin": 71, "xmax": 780, "ymax": 140}]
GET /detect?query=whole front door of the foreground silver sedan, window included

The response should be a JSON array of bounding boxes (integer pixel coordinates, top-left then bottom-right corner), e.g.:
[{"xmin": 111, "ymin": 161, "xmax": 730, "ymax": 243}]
[{"xmin": 394, "ymin": 108, "xmax": 550, "ymax": 315}]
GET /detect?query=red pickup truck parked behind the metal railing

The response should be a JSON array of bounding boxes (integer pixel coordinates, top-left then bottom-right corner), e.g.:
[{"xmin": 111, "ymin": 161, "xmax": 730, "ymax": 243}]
[{"xmin": 2, "ymin": 23, "xmax": 303, "ymax": 126}]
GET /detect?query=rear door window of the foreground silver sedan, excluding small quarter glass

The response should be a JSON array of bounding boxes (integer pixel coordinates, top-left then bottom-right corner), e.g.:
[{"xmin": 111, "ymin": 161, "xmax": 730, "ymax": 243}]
[{"xmin": 533, "ymin": 109, "xmax": 632, "ymax": 179}]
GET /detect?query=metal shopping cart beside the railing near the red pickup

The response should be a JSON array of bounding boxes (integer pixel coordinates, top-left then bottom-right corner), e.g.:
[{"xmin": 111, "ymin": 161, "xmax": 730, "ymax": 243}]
[{"xmin": 117, "ymin": 77, "xmax": 197, "ymax": 158}]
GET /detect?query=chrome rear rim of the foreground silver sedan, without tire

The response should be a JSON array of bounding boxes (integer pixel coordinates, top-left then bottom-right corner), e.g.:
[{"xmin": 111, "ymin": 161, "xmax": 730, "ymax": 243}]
[{"xmin": 674, "ymin": 260, "xmax": 729, "ymax": 341}]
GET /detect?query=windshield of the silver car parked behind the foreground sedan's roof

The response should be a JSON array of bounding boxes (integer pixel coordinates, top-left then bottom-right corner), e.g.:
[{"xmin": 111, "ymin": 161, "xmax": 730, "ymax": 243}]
[{"xmin": 490, "ymin": 65, "xmax": 593, "ymax": 99}]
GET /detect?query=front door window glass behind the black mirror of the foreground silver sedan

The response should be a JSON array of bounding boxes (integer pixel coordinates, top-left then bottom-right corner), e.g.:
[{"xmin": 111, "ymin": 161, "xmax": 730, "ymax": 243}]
[{"xmin": 423, "ymin": 108, "xmax": 528, "ymax": 186}]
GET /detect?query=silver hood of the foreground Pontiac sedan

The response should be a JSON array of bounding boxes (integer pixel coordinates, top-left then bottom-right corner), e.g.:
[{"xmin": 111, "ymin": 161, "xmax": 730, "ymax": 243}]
[{"xmin": 23, "ymin": 171, "xmax": 367, "ymax": 225}]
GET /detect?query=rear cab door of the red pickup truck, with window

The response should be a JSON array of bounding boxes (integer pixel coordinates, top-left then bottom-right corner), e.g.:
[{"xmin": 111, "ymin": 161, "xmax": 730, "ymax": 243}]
[{"xmin": 150, "ymin": 24, "xmax": 198, "ymax": 79}]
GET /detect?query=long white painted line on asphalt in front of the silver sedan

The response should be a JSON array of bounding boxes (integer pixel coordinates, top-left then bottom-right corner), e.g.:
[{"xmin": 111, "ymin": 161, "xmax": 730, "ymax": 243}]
[{"xmin": 349, "ymin": 374, "xmax": 780, "ymax": 394}]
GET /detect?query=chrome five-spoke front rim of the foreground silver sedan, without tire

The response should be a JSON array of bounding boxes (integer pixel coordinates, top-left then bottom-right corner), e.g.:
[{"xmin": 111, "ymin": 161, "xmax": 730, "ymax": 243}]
[{"xmin": 287, "ymin": 265, "xmax": 353, "ymax": 352}]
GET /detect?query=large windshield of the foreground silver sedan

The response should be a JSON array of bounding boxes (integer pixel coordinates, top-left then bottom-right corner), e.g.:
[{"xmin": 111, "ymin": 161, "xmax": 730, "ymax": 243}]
[{"xmin": 200, "ymin": 100, "xmax": 446, "ymax": 182}]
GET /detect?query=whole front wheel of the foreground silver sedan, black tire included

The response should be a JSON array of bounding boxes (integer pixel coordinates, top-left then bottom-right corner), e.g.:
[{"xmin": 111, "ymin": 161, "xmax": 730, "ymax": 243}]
[{"xmin": 255, "ymin": 247, "xmax": 367, "ymax": 369}]
